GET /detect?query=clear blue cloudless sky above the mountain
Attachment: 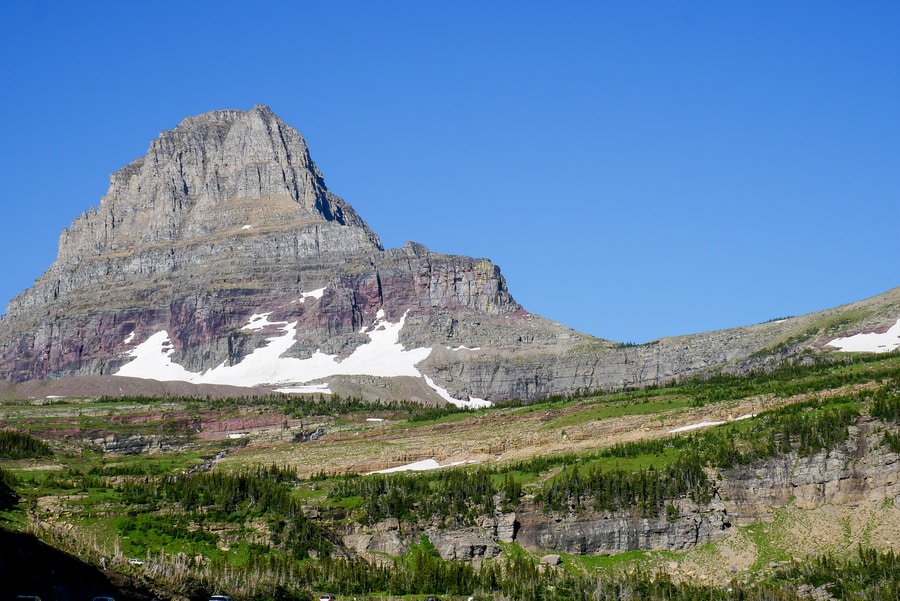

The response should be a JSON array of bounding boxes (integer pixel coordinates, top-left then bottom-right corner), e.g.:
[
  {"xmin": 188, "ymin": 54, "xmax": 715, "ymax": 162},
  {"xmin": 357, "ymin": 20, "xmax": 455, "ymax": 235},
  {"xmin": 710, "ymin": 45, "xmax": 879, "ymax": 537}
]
[{"xmin": 0, "ymin": 0, "xmax": 900, "ymax": 342}]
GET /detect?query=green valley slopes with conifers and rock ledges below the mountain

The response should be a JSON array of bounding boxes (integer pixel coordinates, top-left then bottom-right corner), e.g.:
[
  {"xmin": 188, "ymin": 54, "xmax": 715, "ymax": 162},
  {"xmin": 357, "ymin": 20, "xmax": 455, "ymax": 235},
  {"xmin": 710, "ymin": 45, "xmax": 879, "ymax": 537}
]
[{"xmin": 0, "ymin": 353, "xmax": 900, "ymax": 599}]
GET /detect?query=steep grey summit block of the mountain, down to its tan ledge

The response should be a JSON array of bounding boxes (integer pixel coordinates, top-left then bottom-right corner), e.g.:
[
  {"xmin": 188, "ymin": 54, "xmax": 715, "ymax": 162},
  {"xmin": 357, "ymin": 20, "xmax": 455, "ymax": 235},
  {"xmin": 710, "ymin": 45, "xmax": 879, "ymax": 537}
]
[{"xmin": 74, "ymin": 105, "xmax": 381, "ymax": 258}]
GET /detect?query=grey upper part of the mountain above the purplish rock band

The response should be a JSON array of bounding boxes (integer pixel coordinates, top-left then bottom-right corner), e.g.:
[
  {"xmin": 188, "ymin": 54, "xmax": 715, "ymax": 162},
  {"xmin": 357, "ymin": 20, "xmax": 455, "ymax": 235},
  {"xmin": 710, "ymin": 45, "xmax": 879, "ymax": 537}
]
[{"xmin": 7, "ymin": 105, "xmax": 383, "ymax": 324}]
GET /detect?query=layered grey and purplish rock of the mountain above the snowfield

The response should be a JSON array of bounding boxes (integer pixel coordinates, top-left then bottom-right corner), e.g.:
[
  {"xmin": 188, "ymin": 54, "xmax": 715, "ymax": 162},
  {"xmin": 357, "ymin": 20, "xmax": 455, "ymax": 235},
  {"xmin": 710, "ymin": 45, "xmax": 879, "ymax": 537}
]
[{"xmin": 0, "ymin": 107, "xmax": 566, "ymax": 398}]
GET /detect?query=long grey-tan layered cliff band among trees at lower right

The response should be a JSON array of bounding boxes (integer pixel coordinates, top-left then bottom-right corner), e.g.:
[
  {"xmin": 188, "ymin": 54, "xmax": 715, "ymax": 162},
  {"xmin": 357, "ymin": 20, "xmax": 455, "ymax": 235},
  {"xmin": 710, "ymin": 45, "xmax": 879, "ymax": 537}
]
[{"xmin": 345, "ymin": 419, "xmax": 900, "ymax": 561}]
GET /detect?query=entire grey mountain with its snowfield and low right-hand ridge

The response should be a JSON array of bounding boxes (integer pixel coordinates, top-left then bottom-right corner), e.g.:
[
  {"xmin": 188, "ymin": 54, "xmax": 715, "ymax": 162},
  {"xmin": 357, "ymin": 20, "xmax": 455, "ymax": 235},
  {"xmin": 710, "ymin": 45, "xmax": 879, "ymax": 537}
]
[{"xmin": 0, "ymin": 106, "xmax": 900, "ymax": 405}]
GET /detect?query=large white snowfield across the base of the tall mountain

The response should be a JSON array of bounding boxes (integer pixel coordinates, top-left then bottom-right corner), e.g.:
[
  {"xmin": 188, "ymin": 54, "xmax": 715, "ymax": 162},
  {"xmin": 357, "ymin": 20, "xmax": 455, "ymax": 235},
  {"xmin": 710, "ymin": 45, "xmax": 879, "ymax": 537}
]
[{"xmin": 115, "ymin": 298, "xmax": 491, "ymax": 408}]
